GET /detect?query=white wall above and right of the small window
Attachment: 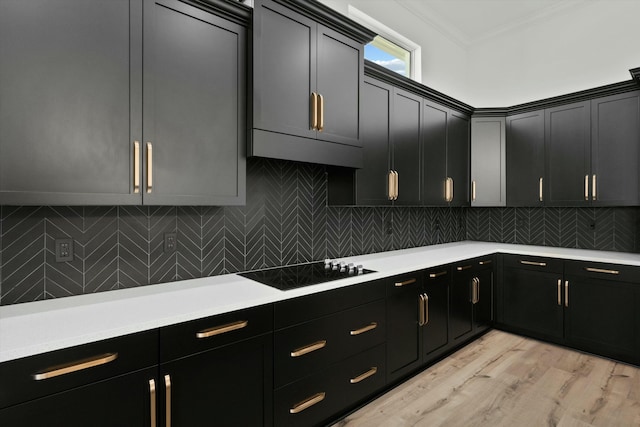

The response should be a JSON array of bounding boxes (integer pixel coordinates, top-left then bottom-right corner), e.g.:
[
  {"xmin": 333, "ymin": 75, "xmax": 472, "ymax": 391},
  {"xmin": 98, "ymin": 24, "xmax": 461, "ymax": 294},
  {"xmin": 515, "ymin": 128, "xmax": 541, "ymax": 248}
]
[{"xmin": 320, "ymin": 0, "xmax": 468, "ymax": 101}]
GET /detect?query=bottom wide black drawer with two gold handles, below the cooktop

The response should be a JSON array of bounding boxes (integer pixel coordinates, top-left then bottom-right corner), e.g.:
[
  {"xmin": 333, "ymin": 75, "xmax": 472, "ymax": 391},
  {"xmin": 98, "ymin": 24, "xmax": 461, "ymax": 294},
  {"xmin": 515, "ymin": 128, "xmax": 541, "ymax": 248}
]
[{"xmin": 274, "ymin": 344, "xmax": 386, "ymax": 426}]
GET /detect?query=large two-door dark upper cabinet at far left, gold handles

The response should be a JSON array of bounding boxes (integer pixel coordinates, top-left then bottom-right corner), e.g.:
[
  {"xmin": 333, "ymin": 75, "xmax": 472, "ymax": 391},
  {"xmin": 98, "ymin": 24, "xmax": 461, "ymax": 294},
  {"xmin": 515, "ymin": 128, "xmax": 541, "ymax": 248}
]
[{"xmin": 0, "ymin": 0, "xmax": 250, "ymax": 205}]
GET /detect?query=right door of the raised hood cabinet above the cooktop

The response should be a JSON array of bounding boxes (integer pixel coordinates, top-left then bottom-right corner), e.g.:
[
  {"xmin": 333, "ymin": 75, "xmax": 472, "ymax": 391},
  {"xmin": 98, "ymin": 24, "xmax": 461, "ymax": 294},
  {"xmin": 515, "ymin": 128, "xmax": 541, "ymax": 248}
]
[{"xmin": 316, "ymin": 25, "xmax": 364, "ymax": 146}]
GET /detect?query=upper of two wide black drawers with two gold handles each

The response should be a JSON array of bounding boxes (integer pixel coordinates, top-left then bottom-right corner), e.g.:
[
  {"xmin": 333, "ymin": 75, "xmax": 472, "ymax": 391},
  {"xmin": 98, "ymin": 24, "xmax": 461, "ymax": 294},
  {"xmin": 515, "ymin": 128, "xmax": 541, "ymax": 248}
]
[{"xmin": 274, "ymin": 300, "xmax": 385, "ymax": 387}]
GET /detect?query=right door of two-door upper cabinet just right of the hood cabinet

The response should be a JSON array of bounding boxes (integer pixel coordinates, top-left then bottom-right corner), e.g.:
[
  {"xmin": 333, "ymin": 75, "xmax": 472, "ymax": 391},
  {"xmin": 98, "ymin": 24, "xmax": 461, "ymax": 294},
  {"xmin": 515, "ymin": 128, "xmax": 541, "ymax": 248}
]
[{"xmin": 391, "ymin": 89, "xmax": 422, "ymax": 205}]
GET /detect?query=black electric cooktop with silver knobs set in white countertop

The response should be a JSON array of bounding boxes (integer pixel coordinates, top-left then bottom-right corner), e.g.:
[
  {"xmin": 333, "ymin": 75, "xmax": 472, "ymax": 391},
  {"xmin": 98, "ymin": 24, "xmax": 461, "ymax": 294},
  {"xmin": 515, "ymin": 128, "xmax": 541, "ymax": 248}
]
[{"xmin": 239, "ymin": 262, "xmax": 375, "ymax": 291}]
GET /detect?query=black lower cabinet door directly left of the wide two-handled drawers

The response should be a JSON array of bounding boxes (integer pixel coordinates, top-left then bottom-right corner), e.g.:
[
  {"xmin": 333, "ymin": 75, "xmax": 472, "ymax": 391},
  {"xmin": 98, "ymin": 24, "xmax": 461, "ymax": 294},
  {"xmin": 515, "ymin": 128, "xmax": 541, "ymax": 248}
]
[{"xmin": 160, "ymin": 334, "xmax": 273, "ymax": 427}]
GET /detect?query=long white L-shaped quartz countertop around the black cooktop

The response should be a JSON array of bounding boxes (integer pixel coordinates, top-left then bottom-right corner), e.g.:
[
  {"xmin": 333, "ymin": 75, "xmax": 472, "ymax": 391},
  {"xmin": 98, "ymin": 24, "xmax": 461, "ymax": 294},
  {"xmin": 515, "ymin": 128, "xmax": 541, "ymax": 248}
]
[{"xmin": 0, "ymin": 242, "xmax": 640, "ymax": 362}]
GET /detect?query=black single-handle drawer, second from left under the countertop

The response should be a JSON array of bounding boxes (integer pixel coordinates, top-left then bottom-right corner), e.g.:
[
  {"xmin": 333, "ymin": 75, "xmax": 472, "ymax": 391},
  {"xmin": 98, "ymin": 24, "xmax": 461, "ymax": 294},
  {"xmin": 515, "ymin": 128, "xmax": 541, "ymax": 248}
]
[{"xmin": 160, "ymin": 304, "xmax": 273, "ymax": 362}]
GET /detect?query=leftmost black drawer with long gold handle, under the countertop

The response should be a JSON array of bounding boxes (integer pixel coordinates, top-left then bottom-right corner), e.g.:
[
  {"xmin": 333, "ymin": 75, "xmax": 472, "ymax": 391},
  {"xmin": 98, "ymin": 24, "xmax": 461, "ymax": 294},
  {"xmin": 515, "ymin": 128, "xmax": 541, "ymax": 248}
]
[{"xmin": 0, "ymin": 330, "xmax": 158, "ymax": 408}]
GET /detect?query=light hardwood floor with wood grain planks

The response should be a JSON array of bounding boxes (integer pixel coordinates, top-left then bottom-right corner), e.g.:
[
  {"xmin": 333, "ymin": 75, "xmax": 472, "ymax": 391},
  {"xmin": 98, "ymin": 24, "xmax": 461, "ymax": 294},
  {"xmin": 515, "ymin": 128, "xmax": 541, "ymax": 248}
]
[{"xmin": 334, "ymin": 330, "xmax": 640, "ymax": 427}]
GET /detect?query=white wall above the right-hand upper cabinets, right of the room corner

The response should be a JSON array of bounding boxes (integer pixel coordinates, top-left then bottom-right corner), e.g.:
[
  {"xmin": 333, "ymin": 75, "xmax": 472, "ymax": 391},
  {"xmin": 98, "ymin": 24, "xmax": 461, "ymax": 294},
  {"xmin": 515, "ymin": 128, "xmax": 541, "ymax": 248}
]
[{"xmin": 464, "ymin": 0, "xmax": 640, "ymax": 107}]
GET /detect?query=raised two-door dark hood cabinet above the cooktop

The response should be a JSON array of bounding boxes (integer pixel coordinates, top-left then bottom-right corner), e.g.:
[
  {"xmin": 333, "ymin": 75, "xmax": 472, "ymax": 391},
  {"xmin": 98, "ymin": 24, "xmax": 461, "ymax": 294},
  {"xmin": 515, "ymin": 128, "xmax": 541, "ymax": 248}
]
[{"xmin": 249, "ymin": 0, "xmax": 375, "ymax": 167}]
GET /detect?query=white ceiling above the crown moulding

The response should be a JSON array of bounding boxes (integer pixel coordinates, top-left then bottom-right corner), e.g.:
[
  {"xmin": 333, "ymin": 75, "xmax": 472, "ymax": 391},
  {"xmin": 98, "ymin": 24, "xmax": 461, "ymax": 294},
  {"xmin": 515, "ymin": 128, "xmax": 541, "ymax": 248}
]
[{"xmin": 393, "ymin": 0, "xmax": 589, "ymax": 47}]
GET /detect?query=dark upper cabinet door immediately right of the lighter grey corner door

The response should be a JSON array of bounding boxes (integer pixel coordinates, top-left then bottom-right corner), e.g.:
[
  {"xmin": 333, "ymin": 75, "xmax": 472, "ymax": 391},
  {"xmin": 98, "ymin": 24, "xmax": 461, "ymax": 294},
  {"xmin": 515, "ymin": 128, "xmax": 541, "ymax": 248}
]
[{"xmin": 506, "ymin": 110, "xmax": 544, "ymax": 206}]
